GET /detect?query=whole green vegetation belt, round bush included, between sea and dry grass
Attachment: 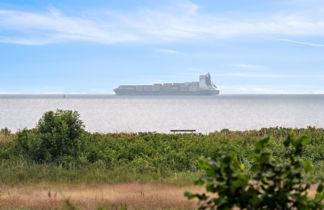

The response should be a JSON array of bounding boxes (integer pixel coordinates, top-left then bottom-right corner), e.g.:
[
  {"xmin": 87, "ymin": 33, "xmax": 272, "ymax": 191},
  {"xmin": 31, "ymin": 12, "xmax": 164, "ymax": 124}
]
[{"xmin": 0, "ymin": 110, "xmax": 324, "ymax": 184}]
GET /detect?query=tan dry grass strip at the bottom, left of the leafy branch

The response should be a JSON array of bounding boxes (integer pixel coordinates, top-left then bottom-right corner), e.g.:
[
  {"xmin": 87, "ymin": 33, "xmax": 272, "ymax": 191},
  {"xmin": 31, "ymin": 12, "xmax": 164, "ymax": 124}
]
[{"xmin": 0, "ymin": 183, "xmax": 202, "ymax": 209}]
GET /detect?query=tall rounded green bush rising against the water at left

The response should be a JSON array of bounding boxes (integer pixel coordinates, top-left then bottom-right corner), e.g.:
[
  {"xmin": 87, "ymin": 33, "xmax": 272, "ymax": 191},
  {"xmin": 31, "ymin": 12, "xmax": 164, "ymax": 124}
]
[{"xmin": 16, "ymin": 110, "xmax": 85, "ymax": 162}]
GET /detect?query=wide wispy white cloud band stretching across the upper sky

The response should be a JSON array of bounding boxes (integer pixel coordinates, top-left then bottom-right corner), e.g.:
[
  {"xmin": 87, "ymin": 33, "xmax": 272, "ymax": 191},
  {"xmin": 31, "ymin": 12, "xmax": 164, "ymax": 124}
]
[{"xmin": 0, "ymin": 1, "xmax": 324, "ymax": 44}]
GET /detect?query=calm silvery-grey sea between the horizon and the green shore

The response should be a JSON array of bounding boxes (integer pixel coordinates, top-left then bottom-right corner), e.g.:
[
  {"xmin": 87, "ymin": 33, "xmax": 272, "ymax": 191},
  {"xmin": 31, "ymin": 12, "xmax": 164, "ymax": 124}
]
[{"xmin": 0, "ymin": 95, "xmax": 324, "ymax": 133}]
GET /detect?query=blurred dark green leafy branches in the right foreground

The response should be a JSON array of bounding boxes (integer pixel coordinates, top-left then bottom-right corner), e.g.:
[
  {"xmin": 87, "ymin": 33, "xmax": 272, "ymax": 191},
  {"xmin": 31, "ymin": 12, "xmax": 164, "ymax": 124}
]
[{"xmin": 185, "ymin": 134, "xmax": 324, "ymax": 209}]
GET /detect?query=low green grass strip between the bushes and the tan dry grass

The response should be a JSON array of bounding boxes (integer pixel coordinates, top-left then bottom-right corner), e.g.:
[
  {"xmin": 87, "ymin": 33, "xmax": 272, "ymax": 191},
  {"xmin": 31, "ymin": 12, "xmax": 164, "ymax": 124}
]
[{"xmin": 0, "ymin": 160, "xmax": 200, "ymax": 186}]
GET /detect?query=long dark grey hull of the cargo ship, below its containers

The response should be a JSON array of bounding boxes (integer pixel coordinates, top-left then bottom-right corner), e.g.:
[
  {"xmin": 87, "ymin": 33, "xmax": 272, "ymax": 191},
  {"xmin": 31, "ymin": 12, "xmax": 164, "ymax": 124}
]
[{"xmin": 114, "ymin": 89, "xmax": 219, "ymax": 96}]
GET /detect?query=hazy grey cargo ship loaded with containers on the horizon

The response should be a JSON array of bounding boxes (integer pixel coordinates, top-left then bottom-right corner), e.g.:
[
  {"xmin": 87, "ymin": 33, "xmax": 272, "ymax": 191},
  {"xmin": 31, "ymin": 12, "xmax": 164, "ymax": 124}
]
[{"xmin": 114, "ymin": 73, "xmax": 219, "ymax": 96}]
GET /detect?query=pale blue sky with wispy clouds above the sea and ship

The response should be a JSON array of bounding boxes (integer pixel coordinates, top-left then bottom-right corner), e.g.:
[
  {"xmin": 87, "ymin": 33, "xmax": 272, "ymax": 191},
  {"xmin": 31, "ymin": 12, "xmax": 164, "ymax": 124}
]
[{"xmin": 0, "ymin": 0, "xmax": 324, "ymax": 94}]
